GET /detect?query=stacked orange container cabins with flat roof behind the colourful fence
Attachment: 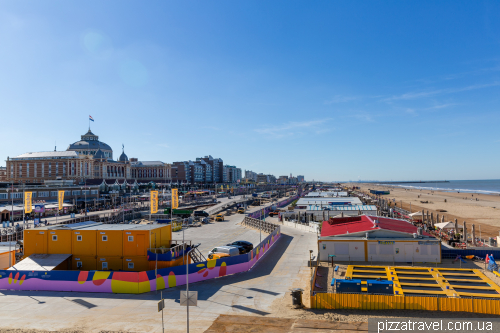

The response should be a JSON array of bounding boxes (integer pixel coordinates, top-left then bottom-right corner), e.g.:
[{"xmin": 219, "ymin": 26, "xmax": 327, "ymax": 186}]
[{"xmin": 24, "ymin": 221, "xmax": 172, "ymax": 271}]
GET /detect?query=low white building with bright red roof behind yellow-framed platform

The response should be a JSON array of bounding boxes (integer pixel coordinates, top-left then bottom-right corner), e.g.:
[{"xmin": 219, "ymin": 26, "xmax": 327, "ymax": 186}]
[{"xmin": 318, "ymin": 215, "xmax": 441, "ymax": 263}]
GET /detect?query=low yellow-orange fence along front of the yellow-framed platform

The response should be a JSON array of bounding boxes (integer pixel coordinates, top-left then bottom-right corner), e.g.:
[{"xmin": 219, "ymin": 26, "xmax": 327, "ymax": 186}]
[{"xmin": 310, "ymin": 292, "xmax": 500, "ymax": 315}]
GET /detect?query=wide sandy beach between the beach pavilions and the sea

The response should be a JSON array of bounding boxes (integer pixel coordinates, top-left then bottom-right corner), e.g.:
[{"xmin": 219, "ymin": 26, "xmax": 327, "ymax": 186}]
[{"xmin": 350, "ymin": 183, "xmax": 500, "ymax": 238}]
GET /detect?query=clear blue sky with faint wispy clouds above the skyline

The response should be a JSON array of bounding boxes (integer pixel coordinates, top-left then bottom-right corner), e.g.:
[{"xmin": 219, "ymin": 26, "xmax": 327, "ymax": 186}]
[{"xmin": 0, "ymin": 1, "xmax": 500, "ymax": 180}]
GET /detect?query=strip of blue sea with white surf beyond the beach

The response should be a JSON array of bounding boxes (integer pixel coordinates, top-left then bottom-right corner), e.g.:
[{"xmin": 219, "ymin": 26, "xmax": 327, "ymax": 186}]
[{"xmin": 379, "ymin": 179, "xmax": 500, "ymax": 195}]
